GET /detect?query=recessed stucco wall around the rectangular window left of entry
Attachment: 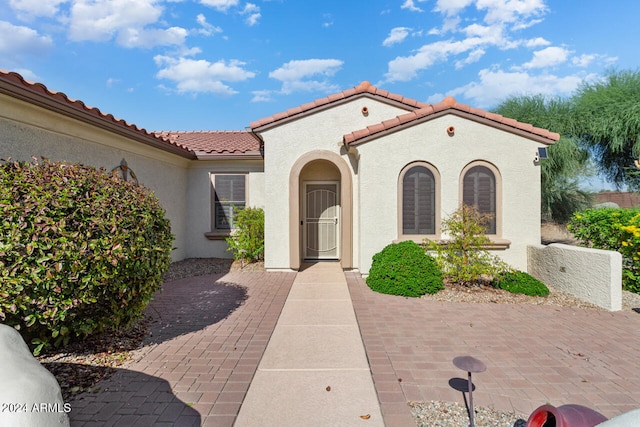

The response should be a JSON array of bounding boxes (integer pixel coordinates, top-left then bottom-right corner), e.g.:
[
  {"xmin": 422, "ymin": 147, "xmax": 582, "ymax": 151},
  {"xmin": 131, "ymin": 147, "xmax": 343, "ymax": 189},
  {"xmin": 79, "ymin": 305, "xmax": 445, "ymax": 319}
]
[{"xmin": 187, "ymin": 160, "xmax": 265, "ymax": 258}]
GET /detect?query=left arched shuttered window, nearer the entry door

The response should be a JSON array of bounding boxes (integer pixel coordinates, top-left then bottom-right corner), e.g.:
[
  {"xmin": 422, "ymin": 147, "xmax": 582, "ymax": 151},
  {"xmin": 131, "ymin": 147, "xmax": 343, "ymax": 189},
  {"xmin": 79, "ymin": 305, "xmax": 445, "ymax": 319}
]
[{"xmin": 400, "ymin": 163, "xmax": 437, "ymax": 236}]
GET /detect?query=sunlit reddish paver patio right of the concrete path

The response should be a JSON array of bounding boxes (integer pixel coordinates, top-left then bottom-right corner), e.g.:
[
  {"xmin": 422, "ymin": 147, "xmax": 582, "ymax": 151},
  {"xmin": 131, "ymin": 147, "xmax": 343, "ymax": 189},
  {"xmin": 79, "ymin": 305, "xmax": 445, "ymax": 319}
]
[{"xmin": 346, "ymin": 273, "xmax": 640, "ymax": 426}]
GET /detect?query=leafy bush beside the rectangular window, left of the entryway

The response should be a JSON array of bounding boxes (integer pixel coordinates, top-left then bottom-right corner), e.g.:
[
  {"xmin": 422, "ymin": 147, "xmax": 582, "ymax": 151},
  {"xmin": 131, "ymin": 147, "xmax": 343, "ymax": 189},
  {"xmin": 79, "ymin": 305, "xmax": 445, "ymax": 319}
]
[{"xmin": 226, "ymin": 208, "xmax": 264, "ymax": 262}]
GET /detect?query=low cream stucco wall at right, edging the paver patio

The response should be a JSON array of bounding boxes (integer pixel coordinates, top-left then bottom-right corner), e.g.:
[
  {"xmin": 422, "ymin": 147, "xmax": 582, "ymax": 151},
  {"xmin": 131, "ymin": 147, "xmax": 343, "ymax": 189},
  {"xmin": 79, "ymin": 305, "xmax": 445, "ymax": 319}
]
[{"xmin": 528, "ymin": 243, "xmax": 622, "ymax": 311}]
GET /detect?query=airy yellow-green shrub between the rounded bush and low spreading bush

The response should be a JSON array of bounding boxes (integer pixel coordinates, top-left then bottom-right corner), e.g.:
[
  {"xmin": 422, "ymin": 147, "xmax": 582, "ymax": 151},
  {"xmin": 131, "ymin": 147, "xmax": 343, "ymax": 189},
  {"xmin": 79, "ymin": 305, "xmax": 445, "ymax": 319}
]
[{"xmin": 427, "ymin": 205, "xmax": 510, "ymax": 286}]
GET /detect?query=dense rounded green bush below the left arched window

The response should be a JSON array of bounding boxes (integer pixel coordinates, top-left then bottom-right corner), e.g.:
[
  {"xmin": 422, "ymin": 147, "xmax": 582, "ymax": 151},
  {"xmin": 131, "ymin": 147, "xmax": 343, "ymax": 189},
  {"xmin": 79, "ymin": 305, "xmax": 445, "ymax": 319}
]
[{"xmin": 366, "ymin": 241, "xmax": 444, "ymax": 297}]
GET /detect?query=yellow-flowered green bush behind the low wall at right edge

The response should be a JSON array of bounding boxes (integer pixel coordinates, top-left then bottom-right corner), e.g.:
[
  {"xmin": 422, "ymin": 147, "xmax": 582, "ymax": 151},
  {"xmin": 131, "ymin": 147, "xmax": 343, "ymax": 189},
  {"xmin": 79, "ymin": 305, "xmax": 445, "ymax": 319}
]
[{"xmin": 567, "ymin": 208, "xmax": 640, "ymax": 294}]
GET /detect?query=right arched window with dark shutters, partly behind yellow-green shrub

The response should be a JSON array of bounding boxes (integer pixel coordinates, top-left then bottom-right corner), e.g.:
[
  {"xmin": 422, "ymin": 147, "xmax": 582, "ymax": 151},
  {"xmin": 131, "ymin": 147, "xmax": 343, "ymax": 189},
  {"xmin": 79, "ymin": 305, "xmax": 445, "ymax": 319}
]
[{"xmin": 462, "ymin": 165, "xmax": 498, "ymax": 234}]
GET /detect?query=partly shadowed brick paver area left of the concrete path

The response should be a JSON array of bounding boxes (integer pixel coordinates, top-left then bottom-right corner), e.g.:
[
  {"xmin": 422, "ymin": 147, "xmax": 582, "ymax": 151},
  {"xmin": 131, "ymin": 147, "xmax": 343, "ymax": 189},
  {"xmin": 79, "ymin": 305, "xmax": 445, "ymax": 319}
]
[{"xmin": 69, "ymin": 272, "xmax": 296, "ymax": 427}]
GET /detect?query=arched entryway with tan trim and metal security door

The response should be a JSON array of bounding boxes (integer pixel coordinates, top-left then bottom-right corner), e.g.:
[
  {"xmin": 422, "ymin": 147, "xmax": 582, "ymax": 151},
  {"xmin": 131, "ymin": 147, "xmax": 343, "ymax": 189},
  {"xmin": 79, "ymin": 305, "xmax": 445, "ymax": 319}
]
[{"xmin": 289, "ymin": 150, "xmax": 353, "ymax": 270}]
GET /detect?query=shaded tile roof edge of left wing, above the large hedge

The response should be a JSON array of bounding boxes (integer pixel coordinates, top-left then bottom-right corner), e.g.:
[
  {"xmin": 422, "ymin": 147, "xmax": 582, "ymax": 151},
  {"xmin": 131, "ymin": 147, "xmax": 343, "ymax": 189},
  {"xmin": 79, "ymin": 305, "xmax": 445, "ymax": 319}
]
[{"xmin": 0, "ymin": 69, "xmax": 193, "ymax": 157}]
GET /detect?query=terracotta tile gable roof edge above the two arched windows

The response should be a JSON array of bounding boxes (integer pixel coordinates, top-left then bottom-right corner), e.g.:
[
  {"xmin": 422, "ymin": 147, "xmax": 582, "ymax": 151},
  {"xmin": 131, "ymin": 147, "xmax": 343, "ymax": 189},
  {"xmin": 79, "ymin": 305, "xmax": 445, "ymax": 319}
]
[{"xmin": 343, "ymin": 96, "xmax": 560, "ymax": 145}]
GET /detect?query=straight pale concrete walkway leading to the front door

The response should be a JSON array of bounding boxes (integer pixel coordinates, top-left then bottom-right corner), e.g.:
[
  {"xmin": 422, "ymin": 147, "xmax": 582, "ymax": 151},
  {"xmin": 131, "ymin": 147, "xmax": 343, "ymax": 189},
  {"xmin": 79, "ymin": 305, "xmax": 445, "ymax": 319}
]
[{"xmin": 235, "ymin": 262, "xmax": 384, "ymax": 427}]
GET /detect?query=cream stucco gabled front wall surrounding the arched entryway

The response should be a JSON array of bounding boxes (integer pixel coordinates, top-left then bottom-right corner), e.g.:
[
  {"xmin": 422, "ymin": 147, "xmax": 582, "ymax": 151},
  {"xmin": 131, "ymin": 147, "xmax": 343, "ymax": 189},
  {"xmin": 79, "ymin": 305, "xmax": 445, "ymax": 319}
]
[{"xmin": 260, "ymin": 98, "xmax": 406, "ymax": 269}]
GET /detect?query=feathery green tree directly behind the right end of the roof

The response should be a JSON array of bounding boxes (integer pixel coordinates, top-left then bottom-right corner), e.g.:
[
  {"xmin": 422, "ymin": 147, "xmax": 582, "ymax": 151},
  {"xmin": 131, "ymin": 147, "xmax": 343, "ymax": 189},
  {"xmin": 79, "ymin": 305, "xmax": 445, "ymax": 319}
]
[{"xmin": 495, "ymin": 95, "xmax": 590, "ymax": 223}]
